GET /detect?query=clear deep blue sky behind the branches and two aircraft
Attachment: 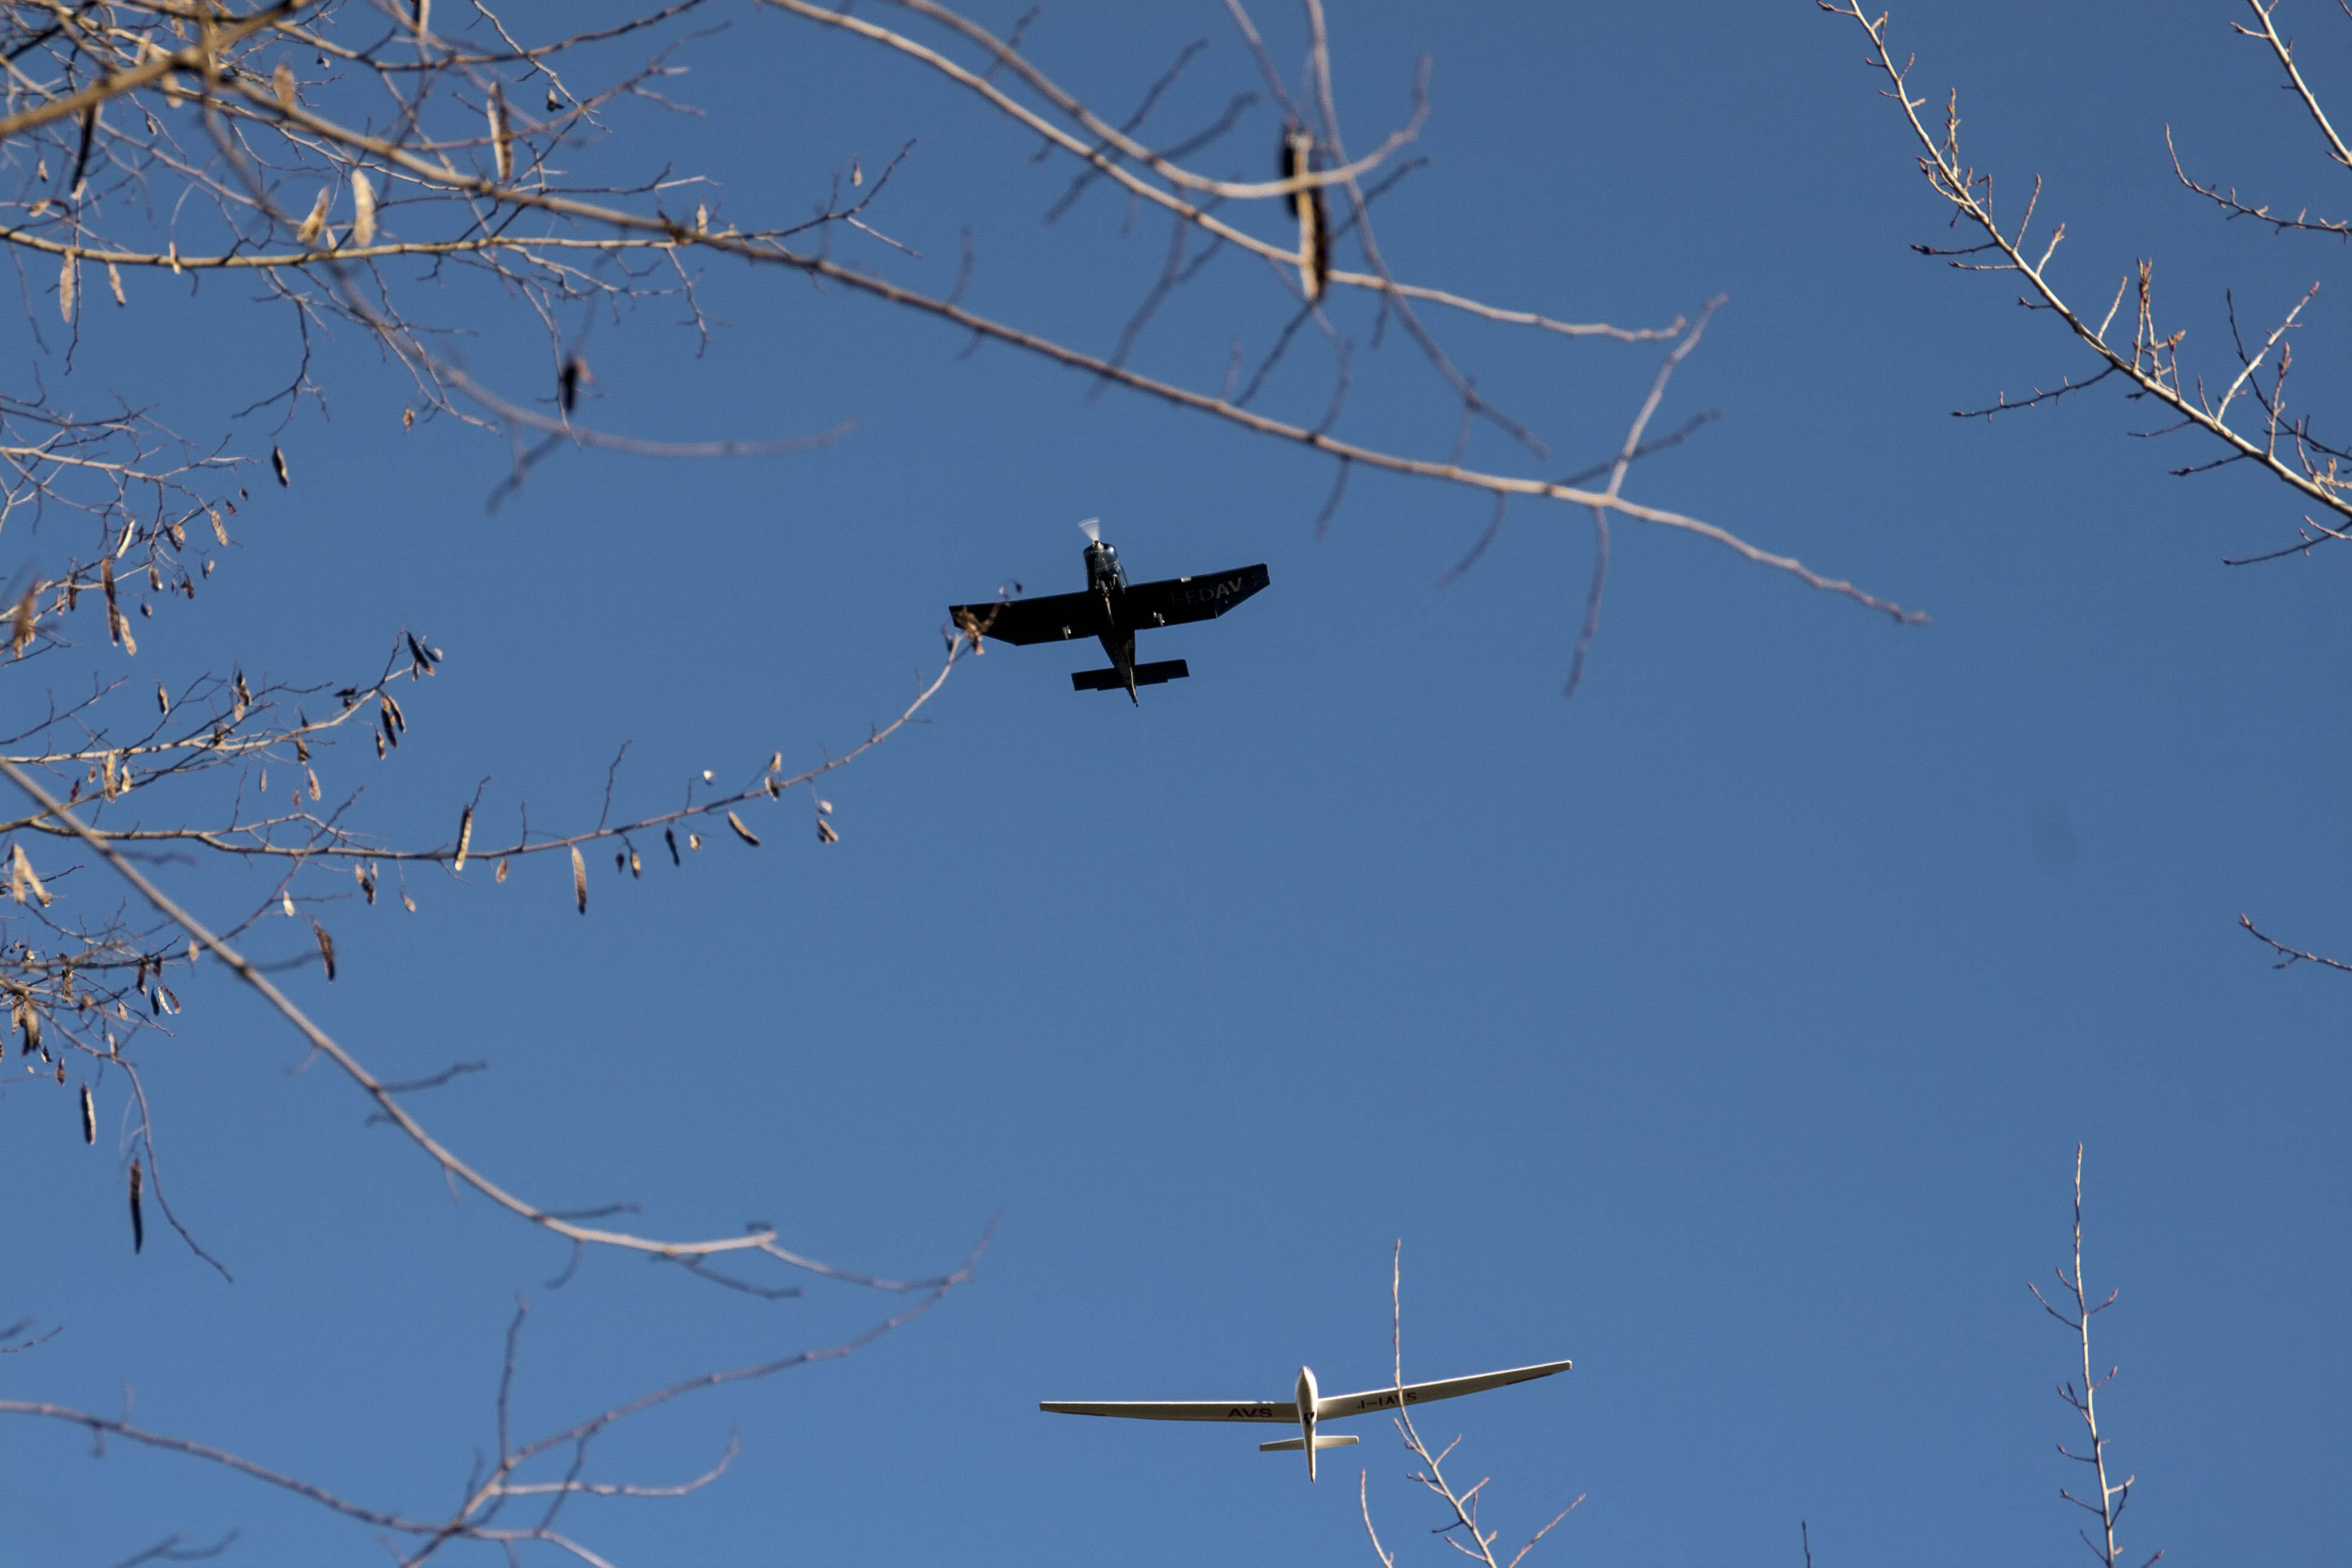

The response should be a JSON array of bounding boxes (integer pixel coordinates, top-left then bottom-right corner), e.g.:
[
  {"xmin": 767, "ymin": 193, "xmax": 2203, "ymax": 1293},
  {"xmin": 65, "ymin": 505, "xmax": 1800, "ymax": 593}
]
[{"xmin": 0, "ymin": 0, "xmax": 2352, "ymax": 1568}]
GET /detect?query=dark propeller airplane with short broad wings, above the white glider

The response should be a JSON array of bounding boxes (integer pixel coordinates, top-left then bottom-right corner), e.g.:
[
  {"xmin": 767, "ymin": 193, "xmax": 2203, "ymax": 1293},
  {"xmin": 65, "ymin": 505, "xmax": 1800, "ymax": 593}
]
[{"xmin": 948, "ymin": 517, "xmax": 1268, "ymax": 705}]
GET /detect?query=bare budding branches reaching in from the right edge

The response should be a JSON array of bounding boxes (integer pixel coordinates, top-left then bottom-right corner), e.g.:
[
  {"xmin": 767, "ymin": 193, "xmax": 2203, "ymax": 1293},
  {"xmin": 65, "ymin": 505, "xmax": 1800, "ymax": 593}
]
[{"xmin": 1818, "ymin": 0, "xmax": 2352, "ymax": 969}]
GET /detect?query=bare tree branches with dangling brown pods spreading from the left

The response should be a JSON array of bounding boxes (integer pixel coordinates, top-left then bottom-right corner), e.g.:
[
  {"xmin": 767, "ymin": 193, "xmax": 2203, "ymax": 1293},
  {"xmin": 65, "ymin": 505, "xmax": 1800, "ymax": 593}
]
[{"xmin": 0, "ymin": 0, "xmax": 1921, "ymax": 1561}]
